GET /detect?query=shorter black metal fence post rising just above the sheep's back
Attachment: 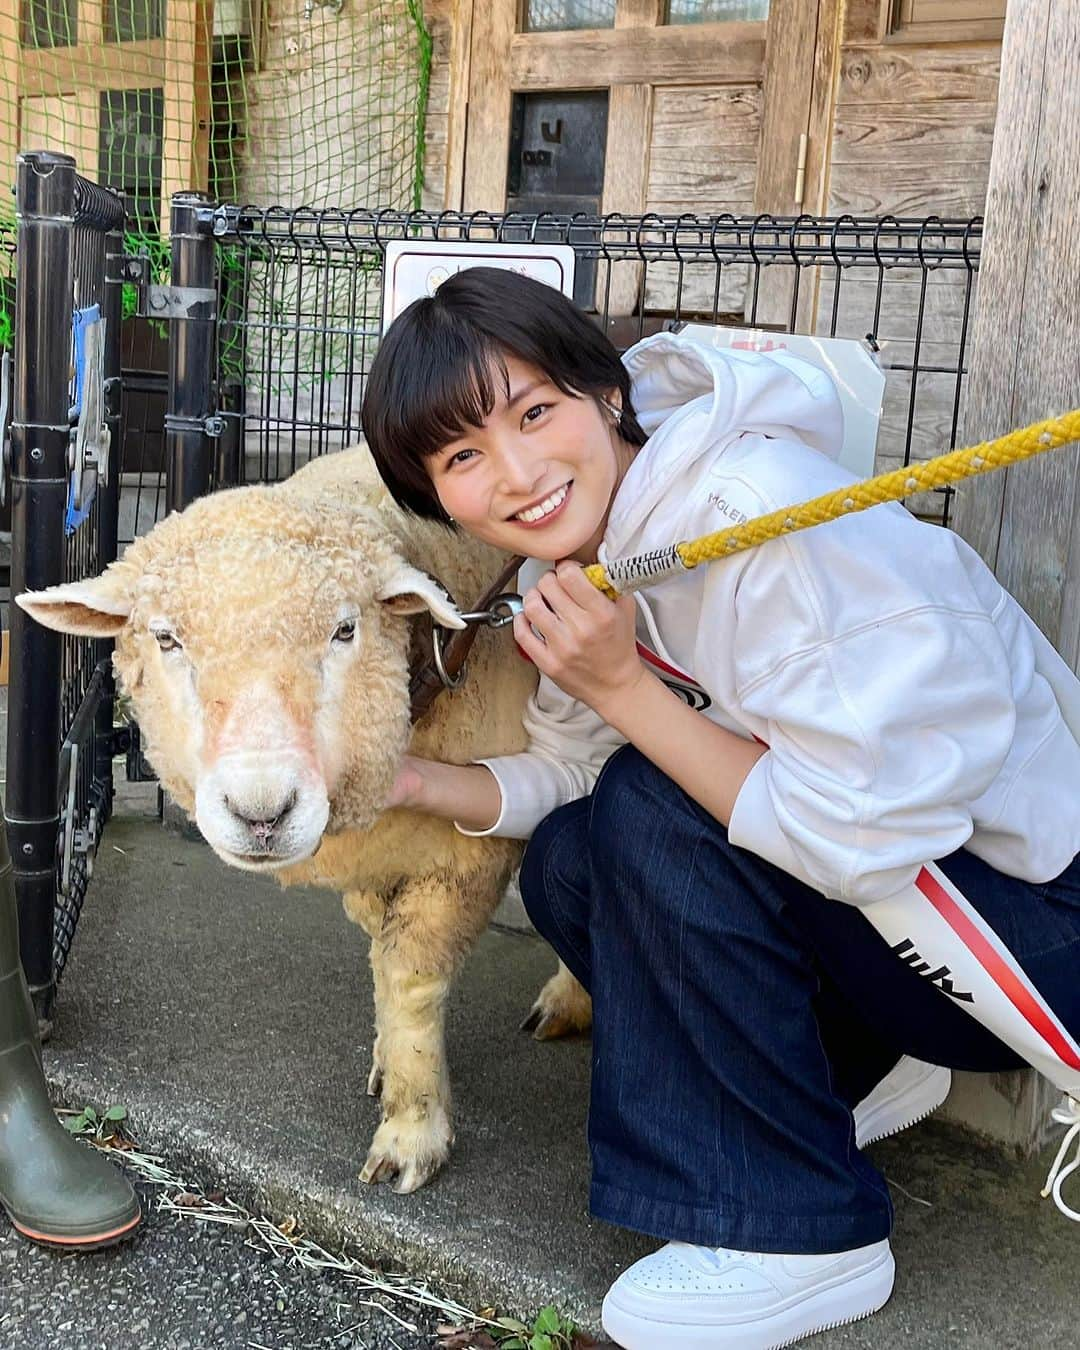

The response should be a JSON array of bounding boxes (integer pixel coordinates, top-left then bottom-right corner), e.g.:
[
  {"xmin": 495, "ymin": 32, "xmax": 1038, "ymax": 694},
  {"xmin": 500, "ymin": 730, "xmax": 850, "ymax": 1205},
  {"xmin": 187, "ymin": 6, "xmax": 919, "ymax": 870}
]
[{"xmin": 165, "ymin": 192, "xmax": 216, "ymax": 512}]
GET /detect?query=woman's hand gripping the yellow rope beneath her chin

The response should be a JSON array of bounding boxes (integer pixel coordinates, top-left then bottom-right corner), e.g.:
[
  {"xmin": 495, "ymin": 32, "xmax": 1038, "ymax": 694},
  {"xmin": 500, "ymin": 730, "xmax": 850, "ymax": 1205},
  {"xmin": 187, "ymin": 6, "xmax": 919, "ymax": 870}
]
[{"xmin": 514, "ymin": 562, "xmax": 647, "ymax": 721}]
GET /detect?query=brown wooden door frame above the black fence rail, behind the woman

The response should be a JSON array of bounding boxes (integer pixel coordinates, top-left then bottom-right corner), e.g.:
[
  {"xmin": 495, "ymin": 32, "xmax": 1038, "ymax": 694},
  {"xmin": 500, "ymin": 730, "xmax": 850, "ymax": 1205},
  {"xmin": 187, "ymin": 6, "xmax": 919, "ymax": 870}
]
[{"xmin": 446, "ymin": 0, "xmax": 844, "ymax": 224}]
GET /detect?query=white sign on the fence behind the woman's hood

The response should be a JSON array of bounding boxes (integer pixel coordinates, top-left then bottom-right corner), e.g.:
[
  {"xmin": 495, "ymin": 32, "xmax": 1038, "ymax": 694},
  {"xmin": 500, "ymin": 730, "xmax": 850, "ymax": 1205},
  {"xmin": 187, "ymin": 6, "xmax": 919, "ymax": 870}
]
[{"xmin": 679, "ymin": 324, "xmax": 886, "ymax": 478}]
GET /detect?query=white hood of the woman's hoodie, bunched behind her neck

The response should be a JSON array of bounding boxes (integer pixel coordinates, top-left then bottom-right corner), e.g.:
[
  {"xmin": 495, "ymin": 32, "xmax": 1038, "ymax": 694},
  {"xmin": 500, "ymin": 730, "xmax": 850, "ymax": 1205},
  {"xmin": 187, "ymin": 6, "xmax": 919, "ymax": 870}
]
[{"xmin": 608, "ymin": 333, "xmax": 844, "ymax": 541}]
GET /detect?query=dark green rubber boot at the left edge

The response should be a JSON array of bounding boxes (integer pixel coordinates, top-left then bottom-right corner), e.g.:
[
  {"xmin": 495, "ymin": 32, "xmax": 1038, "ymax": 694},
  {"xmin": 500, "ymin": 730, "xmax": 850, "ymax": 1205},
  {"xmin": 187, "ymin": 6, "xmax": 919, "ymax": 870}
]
[{"xmin": 0, "ymin": 821, "xmax": 142, "ymax": 1251}]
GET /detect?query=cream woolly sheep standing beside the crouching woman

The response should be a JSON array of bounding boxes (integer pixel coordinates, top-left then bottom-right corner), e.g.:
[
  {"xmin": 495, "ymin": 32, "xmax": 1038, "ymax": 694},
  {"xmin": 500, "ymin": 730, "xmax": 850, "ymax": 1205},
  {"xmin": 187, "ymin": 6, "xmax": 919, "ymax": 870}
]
[{"xmin": 16, "ymin": 448, "xmax": 590, "ymax": 1193}]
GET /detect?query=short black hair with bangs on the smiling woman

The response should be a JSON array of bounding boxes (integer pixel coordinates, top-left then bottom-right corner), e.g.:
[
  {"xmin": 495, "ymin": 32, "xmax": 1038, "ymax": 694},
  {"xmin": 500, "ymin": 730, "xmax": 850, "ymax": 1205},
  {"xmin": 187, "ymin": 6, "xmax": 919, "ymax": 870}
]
[{"xmin": 360, "ymin": 267, "xmax": 645, "ymax": 524}]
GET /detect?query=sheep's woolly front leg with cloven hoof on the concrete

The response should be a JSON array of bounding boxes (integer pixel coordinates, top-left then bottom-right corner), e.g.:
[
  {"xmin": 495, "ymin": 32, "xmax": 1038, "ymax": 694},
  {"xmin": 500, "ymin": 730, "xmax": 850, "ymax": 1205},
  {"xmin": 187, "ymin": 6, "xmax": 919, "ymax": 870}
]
[{"xmin": 360, "ymin": 882, "xmax": 473, "ymax": 1193}]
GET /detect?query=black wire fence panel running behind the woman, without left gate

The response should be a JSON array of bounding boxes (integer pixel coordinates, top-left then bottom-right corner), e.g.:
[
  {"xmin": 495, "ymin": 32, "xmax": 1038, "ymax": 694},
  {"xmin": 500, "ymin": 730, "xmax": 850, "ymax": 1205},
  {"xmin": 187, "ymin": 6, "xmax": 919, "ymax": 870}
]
[{"xmin": 147, "ymin": 207, "xmax": 981, "ymax": 522}]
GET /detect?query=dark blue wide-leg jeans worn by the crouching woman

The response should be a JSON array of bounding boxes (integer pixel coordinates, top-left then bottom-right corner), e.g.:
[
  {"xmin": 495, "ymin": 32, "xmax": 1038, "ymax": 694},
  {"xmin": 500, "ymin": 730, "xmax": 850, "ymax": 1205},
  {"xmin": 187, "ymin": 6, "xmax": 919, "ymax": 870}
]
[{"xmin": 521, "ymin": 747, "xmax": 1080, "ymax": 1253}]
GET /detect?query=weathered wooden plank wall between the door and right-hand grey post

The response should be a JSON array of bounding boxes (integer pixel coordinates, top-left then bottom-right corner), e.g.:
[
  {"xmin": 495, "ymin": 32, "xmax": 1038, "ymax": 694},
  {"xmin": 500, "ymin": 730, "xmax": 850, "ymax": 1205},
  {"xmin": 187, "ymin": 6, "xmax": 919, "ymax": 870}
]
[{"xmin": 817, "ymin": 0, "xmax": 1000, "ymax": 518}]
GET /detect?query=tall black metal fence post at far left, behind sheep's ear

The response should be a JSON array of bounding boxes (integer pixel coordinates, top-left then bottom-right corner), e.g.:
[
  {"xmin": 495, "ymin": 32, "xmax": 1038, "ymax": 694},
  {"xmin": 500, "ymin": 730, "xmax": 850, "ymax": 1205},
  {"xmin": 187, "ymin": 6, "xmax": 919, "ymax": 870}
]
[{"xmin": 4, "ymin": 153, "xmax": 76, "ymax": 1027}]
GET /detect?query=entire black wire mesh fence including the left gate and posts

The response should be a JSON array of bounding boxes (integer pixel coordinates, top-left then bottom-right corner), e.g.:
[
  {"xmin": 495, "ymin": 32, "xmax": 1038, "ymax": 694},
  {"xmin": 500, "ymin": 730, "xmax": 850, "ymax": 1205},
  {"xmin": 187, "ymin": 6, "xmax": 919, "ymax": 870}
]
[{"xmin": 0, "ymin": 195, "xmax": 981, "ymax": 1017}]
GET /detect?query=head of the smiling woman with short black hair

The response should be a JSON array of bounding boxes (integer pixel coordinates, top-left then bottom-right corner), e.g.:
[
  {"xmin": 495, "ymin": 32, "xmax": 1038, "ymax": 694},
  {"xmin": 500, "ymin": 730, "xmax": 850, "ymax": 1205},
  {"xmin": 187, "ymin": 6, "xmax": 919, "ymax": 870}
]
[{"xmin": 362, "ymin": 267, "xmax": 645, "ymax": 526}]
